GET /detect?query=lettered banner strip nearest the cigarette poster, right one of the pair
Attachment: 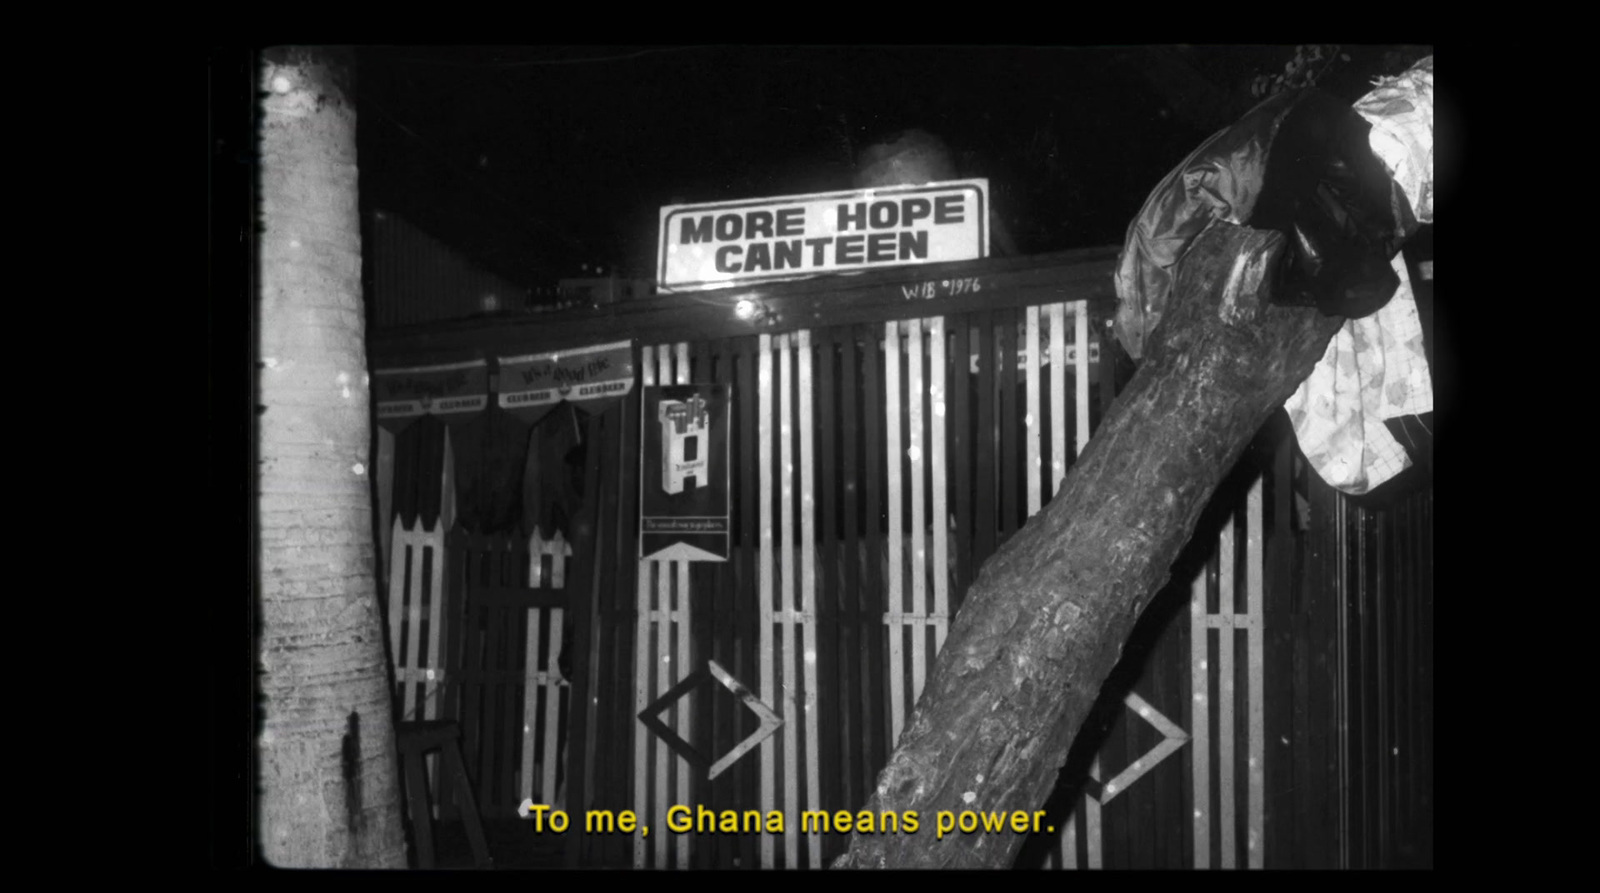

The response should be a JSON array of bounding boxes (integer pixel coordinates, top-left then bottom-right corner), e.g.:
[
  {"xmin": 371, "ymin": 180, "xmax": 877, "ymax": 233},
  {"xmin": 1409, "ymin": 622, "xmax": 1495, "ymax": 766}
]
[{"xmin": 499, "ymin": 341, "xmax": 634, "ymax": 422}]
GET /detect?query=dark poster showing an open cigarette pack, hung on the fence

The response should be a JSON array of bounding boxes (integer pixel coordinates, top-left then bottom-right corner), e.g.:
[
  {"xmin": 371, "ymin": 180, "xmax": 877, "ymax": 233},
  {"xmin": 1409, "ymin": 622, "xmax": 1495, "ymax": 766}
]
[{"xmin": 638, "ymin": 384, "xmax": 731, "ymax": 562}]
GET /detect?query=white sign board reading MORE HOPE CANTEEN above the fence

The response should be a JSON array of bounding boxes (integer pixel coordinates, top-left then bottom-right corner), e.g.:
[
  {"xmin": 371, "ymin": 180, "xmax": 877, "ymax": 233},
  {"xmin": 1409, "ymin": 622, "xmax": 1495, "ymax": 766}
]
[{"xmin": 656, "ymin": 179, "xmax": 989, "ymax": 291}]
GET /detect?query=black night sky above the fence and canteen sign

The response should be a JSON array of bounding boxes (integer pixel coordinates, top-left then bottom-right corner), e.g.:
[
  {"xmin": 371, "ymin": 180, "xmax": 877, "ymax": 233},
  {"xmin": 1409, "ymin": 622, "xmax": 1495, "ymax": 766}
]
[{"xmin": 358, "ymin": 46, "xmax": 1422, "ymax": 296}]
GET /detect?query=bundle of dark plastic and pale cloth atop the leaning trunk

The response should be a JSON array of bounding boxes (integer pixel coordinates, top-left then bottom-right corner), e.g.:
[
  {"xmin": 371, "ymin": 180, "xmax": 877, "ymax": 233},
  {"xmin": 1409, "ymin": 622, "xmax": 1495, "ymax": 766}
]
[{"xmin": 1115, "ymin": 58, "xmax": 1432, "ymax": 493}]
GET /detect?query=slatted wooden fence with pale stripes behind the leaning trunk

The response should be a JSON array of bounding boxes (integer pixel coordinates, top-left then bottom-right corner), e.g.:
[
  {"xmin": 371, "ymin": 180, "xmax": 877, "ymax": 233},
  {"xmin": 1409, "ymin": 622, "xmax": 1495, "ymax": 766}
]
[{"xmin": 378, "ymin": 249, "xmax": 1432, "ymax": 869}]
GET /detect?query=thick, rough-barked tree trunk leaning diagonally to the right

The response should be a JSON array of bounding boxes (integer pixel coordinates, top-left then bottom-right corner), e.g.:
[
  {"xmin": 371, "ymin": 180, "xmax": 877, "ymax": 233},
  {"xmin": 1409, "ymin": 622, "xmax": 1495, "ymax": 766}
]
[{"xmin": 834, "ymin": 222, "xmax": 1344, "ymax": 867}]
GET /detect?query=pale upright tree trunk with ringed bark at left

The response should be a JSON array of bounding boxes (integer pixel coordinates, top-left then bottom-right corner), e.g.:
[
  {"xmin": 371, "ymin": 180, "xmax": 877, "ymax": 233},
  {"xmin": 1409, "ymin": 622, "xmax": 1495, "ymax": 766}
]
[{"xmin": 258, "ymin": 50, "xmax": 405, "ymax": 867}]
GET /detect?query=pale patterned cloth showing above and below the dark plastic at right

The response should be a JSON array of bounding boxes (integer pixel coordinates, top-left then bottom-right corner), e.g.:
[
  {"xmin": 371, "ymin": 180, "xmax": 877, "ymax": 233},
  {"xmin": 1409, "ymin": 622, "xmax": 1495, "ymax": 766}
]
[{"xmin": 1283, "ymin": 56, "xmax": 1434, "ymax": 493}]
